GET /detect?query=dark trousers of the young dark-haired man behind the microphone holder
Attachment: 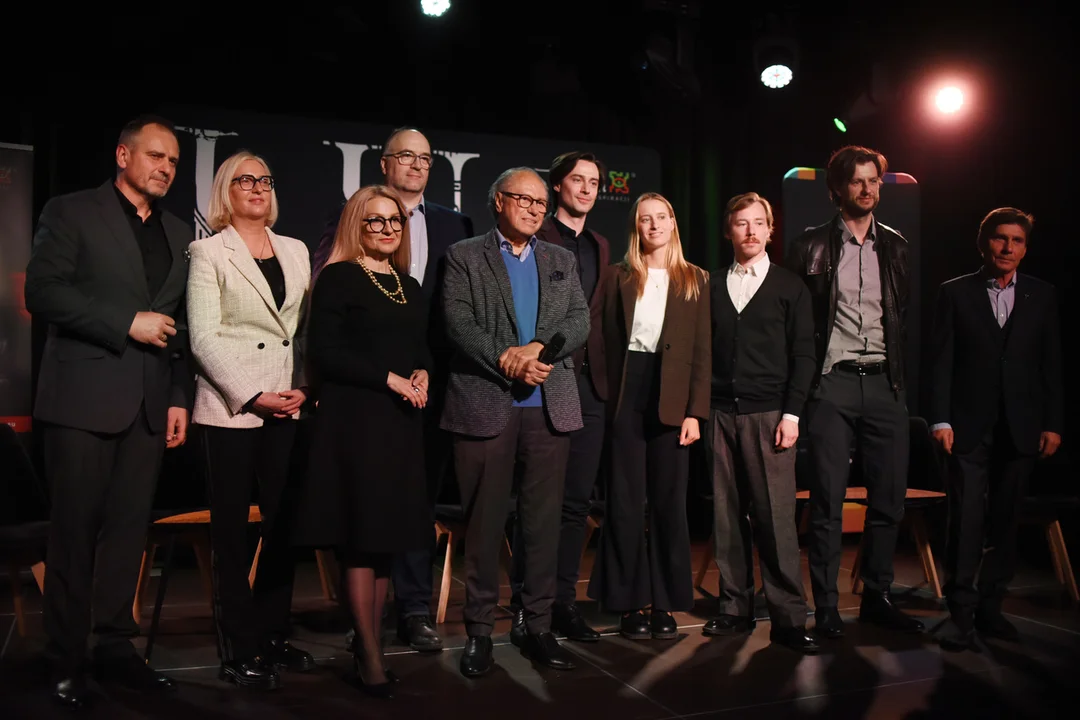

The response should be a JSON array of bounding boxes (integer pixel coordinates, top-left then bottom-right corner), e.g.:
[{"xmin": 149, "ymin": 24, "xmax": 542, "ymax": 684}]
[{"xmin": 511, "ymin": 366, "xmax": 607, "ymax": 607}]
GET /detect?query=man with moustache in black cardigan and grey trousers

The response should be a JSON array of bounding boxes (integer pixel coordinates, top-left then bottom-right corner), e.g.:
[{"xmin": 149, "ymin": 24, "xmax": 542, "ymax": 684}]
[{"xmin": 703, "ymin": 192, "xmax": 819, "ymax": 653}]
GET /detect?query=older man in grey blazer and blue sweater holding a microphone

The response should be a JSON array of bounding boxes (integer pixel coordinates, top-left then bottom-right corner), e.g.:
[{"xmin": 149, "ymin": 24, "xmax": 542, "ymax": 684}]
[{"xmin": 442, "ymin": 167, "xmax": 590, "ymax": 677}]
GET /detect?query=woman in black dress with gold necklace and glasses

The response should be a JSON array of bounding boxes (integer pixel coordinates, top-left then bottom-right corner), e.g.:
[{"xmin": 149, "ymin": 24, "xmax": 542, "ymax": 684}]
[{"xmin": 297, "ymin": 186, "xmax": 434, "ymax": 696}]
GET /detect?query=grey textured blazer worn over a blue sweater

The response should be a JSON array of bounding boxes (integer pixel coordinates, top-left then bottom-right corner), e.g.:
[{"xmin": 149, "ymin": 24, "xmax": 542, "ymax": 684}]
[{"xmin": 442, "ymin": 229, "xmax": 589, "ymax": 437}]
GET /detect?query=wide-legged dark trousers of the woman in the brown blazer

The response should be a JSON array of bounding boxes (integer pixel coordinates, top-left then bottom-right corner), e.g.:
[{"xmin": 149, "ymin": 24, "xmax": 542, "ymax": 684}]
[{"xmin": 589, "ymin": 352, "xmax": 693, "ymax": 612}]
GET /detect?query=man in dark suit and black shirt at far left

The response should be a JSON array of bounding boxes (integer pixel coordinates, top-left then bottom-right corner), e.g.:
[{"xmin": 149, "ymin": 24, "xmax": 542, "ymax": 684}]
[{"xmin": 26, "ymin": 117, "xmax": 192, "ymax": 706}]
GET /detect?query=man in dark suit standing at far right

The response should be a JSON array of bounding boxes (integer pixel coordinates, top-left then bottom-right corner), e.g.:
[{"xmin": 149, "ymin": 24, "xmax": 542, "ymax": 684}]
[{"xmin": 930, "ymin": 207, "xmax": 1064, "ymax": 650}]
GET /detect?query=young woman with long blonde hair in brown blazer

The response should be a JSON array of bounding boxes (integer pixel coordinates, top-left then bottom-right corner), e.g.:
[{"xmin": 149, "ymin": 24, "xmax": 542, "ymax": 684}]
[{"xmin": 589, "ymin": 193, "xmax": 712, "ymax": 640}]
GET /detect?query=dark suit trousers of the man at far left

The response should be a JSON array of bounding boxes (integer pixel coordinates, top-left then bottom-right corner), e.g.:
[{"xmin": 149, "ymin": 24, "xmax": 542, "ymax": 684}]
[{"xmin": 42, "ymin": 408, "xmax": 165, "ymax": 670}]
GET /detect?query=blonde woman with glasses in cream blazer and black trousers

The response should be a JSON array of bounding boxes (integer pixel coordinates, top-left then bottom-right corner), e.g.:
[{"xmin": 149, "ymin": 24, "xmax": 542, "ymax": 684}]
[{"xmin": 187, "ymin": 152, "xmax": 314, "ymax": 690}]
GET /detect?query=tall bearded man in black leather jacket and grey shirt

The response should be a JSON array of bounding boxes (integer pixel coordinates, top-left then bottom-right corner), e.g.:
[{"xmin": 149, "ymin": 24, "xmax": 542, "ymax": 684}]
[{"xmin": 788, "ymin": 146, "xmax": 923, "ymax": 638}]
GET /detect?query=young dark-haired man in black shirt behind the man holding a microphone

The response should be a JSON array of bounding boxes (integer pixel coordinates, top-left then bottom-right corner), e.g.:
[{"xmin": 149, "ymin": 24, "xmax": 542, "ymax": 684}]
[{"xmin": 510, "ymin": 151, "xmax": 611, "ymax": 646}]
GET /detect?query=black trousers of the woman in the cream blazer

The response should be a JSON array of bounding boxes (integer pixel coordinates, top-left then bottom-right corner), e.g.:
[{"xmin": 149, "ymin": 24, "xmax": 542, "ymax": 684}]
[{"xmin": 194, "ymin": 419, "xmax": 297, "ymax": 662}]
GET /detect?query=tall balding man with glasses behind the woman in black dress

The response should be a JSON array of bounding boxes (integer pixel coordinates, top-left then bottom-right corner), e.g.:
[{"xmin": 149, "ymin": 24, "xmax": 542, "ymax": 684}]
[{"xmin": 312, "ymin": 127, "xmax": 473, "ymax": 652}]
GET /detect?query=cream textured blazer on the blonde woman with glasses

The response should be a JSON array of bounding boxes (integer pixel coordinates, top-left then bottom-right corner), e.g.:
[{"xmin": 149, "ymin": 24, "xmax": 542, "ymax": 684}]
[{"xmin": 188, "ymin": 226, "xmax": 311, "ymax": 427}]
